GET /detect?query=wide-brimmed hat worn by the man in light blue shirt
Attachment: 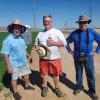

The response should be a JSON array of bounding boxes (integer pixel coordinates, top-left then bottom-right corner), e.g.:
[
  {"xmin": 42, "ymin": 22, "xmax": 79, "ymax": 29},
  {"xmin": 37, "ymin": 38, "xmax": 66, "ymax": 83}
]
[{"xmin": 7, "ymin": 19, "xmax": 26, "ymax": 34}]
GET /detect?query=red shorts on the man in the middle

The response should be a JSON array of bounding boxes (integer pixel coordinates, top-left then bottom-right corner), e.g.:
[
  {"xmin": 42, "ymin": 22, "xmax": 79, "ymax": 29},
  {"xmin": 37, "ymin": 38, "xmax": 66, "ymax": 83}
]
[{"xmin": 39, "ymin": 58, "xmax": 62, "ymax": 75}]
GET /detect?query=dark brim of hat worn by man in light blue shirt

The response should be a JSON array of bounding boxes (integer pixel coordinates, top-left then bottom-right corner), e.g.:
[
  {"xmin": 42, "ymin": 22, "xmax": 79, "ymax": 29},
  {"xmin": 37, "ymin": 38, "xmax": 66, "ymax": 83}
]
[{"xmin": 7, "ymin": 24, "xmax": 26, "ymax": 34}]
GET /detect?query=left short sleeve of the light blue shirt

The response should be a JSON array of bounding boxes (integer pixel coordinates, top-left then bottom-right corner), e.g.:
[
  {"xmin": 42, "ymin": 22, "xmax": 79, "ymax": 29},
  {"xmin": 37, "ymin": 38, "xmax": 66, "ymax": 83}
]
[{"xmin": 1, "ymin": 39, "xmax": 10, "ymax": 55}]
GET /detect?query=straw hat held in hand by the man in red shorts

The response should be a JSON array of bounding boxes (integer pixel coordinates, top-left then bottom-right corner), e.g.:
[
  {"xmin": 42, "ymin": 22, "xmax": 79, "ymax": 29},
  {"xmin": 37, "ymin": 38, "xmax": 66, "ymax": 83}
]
[{"xmin": 37, "ymin": 44, "xmax": 51, "ymax": 59}]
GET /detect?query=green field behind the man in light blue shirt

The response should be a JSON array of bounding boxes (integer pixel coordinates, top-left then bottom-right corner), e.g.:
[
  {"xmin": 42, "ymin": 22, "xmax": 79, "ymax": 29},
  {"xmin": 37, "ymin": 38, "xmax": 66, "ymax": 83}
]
[{"xmin": 0, "ymin": 32, "xmax": 38, "ymax": 91}]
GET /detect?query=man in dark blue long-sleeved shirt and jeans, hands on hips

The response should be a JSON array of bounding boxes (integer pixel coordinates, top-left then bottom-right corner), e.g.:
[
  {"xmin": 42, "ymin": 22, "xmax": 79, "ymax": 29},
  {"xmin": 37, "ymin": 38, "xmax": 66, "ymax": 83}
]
[{"xmin": 66, "ymin": 15, "xmax": 100, "ymax": 100}]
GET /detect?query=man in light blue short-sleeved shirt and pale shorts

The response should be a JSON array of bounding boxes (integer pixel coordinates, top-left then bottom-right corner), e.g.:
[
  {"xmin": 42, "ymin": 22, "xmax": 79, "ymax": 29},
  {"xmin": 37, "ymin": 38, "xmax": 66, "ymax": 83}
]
[{"xmin": 1, "ymin": 19, "xmax": 34, "ymax": 100}]
